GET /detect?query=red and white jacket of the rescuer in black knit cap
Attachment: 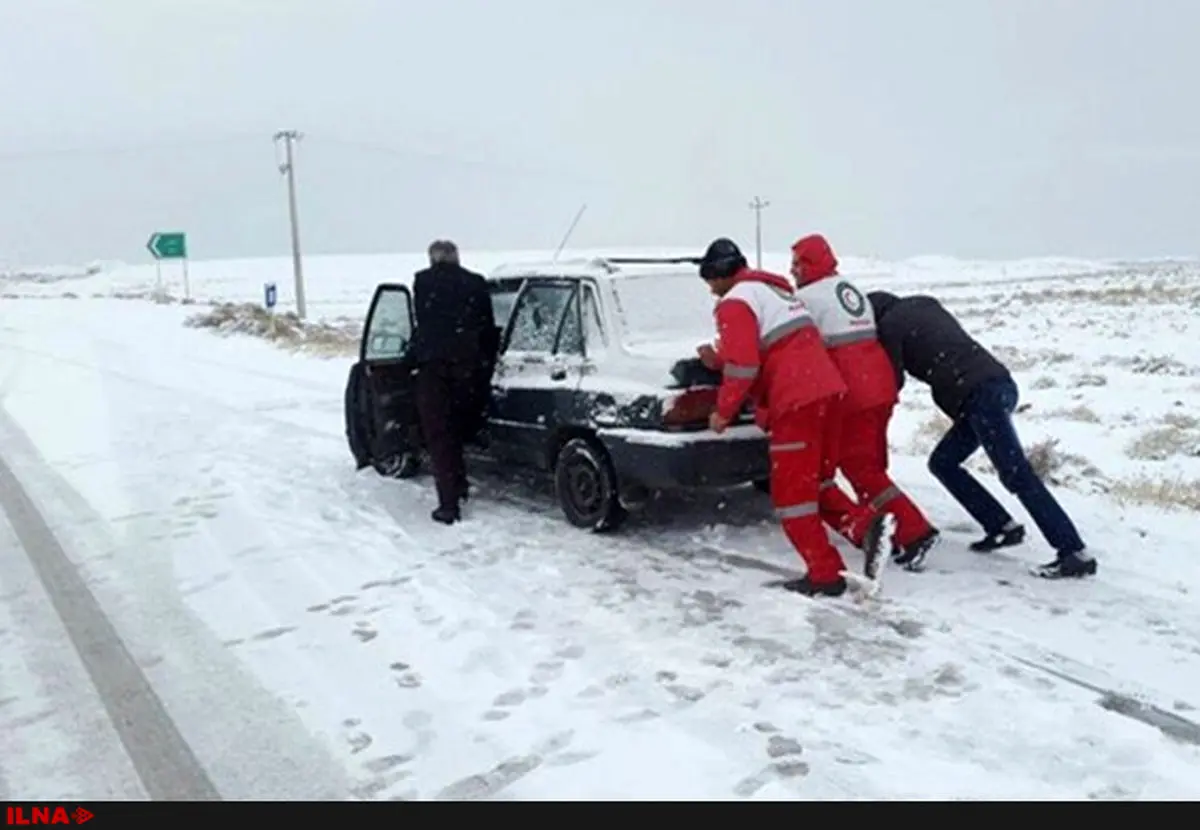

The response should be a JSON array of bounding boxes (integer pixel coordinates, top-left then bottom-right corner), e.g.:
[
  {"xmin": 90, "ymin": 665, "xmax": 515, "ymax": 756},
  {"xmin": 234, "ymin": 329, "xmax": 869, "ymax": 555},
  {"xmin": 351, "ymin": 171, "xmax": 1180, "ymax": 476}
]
[{"xmin": 715, "ymin": 269, "xmax": 846, "ymax": 429}]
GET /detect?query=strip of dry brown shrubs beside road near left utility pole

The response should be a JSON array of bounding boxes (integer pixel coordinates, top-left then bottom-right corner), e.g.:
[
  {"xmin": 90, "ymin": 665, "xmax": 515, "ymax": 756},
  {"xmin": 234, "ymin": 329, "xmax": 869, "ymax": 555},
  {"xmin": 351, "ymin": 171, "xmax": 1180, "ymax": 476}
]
[{"xmin": 184, "ymin": 302, "xmax": 361, "ymax": 357}]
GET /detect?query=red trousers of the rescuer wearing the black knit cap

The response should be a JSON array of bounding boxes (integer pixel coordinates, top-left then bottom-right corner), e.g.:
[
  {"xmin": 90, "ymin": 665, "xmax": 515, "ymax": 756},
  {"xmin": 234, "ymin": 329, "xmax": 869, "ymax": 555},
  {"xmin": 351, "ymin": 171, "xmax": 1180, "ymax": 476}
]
[{"xmin": 770, "ymin": 399, "xmax": 857, "ymax": 584}]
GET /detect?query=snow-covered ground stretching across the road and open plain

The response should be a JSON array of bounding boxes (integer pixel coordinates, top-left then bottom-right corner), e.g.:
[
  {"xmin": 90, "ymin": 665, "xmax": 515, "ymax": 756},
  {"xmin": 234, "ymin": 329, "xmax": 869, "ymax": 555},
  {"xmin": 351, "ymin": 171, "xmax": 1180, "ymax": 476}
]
[{"xmin": 0, "ymin": 252, "xmax": 1200, "ymax": 801}]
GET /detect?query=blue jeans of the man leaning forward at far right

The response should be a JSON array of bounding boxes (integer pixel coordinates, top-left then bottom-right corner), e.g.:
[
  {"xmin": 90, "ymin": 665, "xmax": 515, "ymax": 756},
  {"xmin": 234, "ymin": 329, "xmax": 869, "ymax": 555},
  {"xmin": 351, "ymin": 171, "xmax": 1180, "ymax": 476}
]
[{"xmin": 929, "ymin": 378, "xmax": 1084, "ymax": 553}]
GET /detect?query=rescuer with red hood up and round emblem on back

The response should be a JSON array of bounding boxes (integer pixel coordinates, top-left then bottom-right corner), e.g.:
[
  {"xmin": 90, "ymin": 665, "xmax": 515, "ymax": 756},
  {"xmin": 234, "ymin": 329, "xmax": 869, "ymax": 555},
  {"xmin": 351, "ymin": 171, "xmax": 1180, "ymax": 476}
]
[{"xmin": 792, "ymin": 234, "xmax": 938, "ymax": 570}]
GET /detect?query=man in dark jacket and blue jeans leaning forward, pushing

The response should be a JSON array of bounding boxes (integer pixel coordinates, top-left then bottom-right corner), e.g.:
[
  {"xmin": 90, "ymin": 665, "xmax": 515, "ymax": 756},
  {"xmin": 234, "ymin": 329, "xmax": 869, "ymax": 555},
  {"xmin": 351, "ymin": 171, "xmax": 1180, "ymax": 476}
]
[{"xmin": 868, "ymin": 291, "xmax": 1096, "ymax": 579}]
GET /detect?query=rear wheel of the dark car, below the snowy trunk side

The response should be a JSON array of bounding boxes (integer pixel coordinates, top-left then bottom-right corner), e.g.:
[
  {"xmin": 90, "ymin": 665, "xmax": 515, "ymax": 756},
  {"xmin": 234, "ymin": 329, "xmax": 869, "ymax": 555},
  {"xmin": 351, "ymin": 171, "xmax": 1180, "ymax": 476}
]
[{"xmin": 554, "ymin": 438, "xmax": 625, "ymax": 533}]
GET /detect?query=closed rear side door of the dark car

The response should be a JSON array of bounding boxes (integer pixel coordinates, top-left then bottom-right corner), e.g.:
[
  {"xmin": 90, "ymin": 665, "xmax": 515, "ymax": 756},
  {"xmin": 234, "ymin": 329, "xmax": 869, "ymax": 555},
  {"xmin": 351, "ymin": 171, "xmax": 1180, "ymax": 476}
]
[{"xmin": 488, "ymin": 275, "xmax": 586, "ymax": 468}]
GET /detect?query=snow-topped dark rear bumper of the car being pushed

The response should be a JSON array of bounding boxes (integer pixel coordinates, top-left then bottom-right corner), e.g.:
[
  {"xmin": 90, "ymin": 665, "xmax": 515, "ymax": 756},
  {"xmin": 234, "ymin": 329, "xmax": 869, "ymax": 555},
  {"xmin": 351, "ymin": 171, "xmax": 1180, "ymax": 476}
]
[{"xmin": 598, "ymin": 425, "xmax": 770, "ymax": 489}]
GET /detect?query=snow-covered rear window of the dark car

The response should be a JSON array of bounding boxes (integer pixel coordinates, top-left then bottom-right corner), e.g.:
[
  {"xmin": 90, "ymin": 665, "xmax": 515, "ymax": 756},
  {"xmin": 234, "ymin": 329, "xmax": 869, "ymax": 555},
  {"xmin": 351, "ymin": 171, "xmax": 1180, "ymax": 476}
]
[{"xmin": 614, "ymin": 273, "xmax": 716, "ymax": 345}]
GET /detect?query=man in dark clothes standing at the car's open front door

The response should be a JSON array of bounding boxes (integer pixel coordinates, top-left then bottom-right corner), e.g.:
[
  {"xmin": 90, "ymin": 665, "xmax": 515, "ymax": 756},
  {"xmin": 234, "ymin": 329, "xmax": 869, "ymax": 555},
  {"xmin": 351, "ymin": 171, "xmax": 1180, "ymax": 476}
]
[{"xmin": 412, "ymin": 240, "xmax": 499, "ymax": 524}]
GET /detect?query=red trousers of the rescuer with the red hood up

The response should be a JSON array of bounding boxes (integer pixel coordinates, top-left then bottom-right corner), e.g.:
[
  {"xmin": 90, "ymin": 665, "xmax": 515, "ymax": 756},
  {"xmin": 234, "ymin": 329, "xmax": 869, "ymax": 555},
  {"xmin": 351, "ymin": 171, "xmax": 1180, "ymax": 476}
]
[{"xmin": 827, "ymin": 404, "xmax": 932, "ymax": 547}]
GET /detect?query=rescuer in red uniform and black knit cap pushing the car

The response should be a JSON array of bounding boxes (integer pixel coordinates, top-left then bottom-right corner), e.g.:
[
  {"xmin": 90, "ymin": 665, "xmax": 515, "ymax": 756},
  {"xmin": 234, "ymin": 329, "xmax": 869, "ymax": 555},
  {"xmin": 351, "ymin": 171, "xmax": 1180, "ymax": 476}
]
[{"xmin": 700, "ymin": 239, "xmax": 884, "ymax": 596}]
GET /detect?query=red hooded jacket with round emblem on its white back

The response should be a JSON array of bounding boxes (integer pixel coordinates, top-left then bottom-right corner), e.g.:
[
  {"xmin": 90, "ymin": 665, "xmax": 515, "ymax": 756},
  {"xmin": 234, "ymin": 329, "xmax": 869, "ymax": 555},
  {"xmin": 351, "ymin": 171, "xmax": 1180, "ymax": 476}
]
[{"xmin": 792, "ymin": 234, "xmax": 899, "ymax": 413}]
